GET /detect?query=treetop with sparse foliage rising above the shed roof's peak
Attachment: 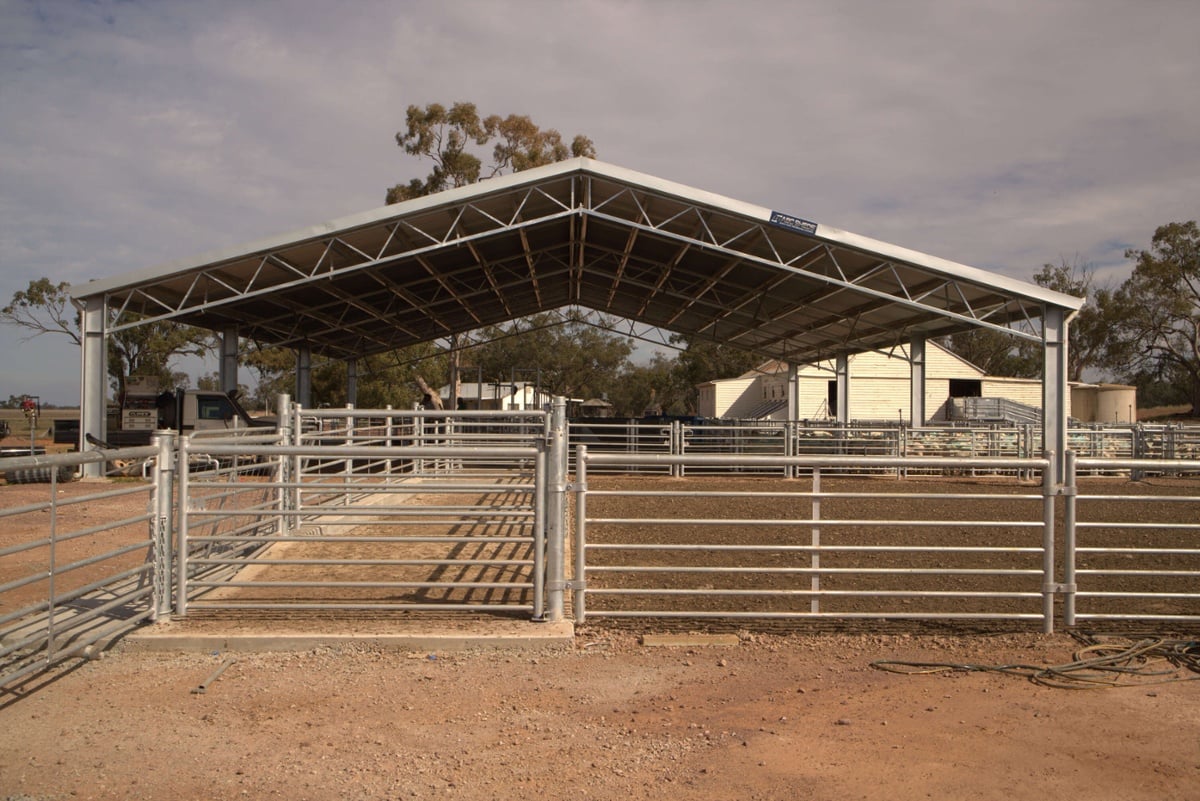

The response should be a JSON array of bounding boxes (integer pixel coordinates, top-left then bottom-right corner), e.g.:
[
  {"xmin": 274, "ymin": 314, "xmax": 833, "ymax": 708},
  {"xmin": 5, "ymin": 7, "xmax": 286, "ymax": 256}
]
[{"xmin": 386, "ymin": 102, "xmax": 595, "ymax": 203}]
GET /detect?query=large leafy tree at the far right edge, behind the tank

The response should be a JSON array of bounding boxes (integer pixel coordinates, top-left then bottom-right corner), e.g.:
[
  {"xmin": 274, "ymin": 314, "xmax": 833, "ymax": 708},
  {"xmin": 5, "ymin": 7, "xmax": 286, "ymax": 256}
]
[{"xmin": 1108, "ymin": 221, "xmax": 1200, "ymax": 415}]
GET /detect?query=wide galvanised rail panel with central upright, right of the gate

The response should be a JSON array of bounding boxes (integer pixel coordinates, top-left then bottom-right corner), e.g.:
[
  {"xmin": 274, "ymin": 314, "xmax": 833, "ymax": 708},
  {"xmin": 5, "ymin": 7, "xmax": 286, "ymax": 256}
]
[{"xmin": 570, "ymin": 448, "xmax": 1057, "ymax": 631}]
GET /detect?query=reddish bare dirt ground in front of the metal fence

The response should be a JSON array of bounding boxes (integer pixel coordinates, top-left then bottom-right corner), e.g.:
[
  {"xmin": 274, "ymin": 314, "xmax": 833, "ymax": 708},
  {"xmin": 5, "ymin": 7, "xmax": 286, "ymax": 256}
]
[{"xmin": 0, "ymin": 455, "xmax": 1200, "ymax": 801}]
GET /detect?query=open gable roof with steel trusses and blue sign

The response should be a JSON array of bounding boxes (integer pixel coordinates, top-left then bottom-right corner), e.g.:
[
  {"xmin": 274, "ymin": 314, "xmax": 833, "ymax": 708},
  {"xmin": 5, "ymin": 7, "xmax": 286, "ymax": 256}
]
[{"xmin": 71, "ymin": 158, "xmax": 1084, "ymax": 363}]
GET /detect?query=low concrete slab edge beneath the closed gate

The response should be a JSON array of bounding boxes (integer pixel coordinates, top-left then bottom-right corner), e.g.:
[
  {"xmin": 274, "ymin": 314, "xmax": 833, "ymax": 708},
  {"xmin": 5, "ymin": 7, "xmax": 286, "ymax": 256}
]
[{"xmin": 121, "ymin": 621, "xmax": 575, "ymax": 654}]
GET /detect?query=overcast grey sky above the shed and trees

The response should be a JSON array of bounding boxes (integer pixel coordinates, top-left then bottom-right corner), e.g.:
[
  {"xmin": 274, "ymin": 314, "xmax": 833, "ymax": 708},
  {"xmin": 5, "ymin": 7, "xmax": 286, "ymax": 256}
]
[{"xmin": 0, "ymin": 0, "xmax": 1200, "ymax": 405}]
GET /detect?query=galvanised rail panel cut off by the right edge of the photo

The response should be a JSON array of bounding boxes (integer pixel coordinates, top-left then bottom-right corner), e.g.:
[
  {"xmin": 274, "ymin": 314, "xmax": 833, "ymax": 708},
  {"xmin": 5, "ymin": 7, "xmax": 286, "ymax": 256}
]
[{"xmin": 1064, "ymin": 453, "xmax": 1200, "ymax": 626}]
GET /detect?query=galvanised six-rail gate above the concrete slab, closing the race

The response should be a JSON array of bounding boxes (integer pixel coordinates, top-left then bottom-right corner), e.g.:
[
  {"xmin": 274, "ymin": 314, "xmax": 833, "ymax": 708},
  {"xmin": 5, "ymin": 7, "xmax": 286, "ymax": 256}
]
[{"xmin": 175, "ymin": 442, "xmax": 545, "ymax": 616}]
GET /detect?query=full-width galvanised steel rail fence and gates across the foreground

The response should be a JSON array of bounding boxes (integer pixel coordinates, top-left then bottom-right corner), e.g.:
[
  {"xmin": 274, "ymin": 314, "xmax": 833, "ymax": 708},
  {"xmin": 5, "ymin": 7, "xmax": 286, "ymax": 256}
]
[{"xmin": 0, "ymin": 404, "xmax": 1200, "ymax": 683}]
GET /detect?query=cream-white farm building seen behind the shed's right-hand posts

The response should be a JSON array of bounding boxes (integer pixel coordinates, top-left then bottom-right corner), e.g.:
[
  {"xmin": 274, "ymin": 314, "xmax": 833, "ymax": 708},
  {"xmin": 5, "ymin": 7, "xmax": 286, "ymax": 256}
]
[{"xmin": 696, "ymin": 342, "xmax": 1070, "ymax": 423}]
